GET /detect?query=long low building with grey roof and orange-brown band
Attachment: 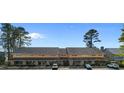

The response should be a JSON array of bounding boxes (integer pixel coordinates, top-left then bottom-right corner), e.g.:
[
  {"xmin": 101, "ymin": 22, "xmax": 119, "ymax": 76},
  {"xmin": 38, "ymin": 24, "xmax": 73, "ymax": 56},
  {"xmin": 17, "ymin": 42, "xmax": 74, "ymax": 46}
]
[{"xmin": 10, "ymin": 48, "xmax": 105, "ymax": 66}]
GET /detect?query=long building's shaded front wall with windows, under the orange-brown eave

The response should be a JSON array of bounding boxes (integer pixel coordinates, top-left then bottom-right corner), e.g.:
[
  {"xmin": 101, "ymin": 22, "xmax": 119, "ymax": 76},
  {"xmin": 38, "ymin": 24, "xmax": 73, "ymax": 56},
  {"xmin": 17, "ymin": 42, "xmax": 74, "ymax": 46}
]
[{"xmin": 10, "ymin": 54, "xmax": 104, "ymax": 66}]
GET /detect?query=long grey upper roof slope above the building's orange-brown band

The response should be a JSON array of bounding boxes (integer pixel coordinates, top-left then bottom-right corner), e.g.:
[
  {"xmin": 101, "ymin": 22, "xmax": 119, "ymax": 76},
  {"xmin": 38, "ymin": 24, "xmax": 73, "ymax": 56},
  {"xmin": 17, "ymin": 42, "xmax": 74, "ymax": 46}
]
[{"xmin": 14, "ymin": 47, "xmax": 103, "ymax": 56}]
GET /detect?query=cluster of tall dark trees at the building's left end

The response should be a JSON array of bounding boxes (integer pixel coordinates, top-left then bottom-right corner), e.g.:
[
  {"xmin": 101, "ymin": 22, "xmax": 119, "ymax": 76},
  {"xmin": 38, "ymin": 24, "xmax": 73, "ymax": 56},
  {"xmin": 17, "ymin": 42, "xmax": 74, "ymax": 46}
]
[{"xmin": 1, "ymin": 23, "xmax": 31, "ymax": 59}]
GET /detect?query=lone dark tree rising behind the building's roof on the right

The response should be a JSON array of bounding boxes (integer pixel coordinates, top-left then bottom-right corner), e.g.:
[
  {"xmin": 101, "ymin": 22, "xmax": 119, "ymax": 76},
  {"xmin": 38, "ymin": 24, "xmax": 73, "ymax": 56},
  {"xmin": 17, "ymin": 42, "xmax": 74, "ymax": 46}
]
[{"xmin": 84, "ymin": 29, "xmax": 101, "ymax": 48}]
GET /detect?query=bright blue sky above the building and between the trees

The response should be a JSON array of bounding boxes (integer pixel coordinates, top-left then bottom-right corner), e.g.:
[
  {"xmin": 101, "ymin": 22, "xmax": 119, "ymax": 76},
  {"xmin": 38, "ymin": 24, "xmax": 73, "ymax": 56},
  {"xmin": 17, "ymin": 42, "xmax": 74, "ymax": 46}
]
[{"xmin": 0, "ymin": 23, "xmax": 123, "ymax": 48}]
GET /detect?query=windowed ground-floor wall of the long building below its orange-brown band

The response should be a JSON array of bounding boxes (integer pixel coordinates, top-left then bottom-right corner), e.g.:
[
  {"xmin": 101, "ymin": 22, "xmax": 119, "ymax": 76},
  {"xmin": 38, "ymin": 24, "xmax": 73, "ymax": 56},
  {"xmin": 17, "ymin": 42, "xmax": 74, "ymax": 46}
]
[{"xmin": 10, "ymin": 59, "xmax": 104, "ymax": 66}]
